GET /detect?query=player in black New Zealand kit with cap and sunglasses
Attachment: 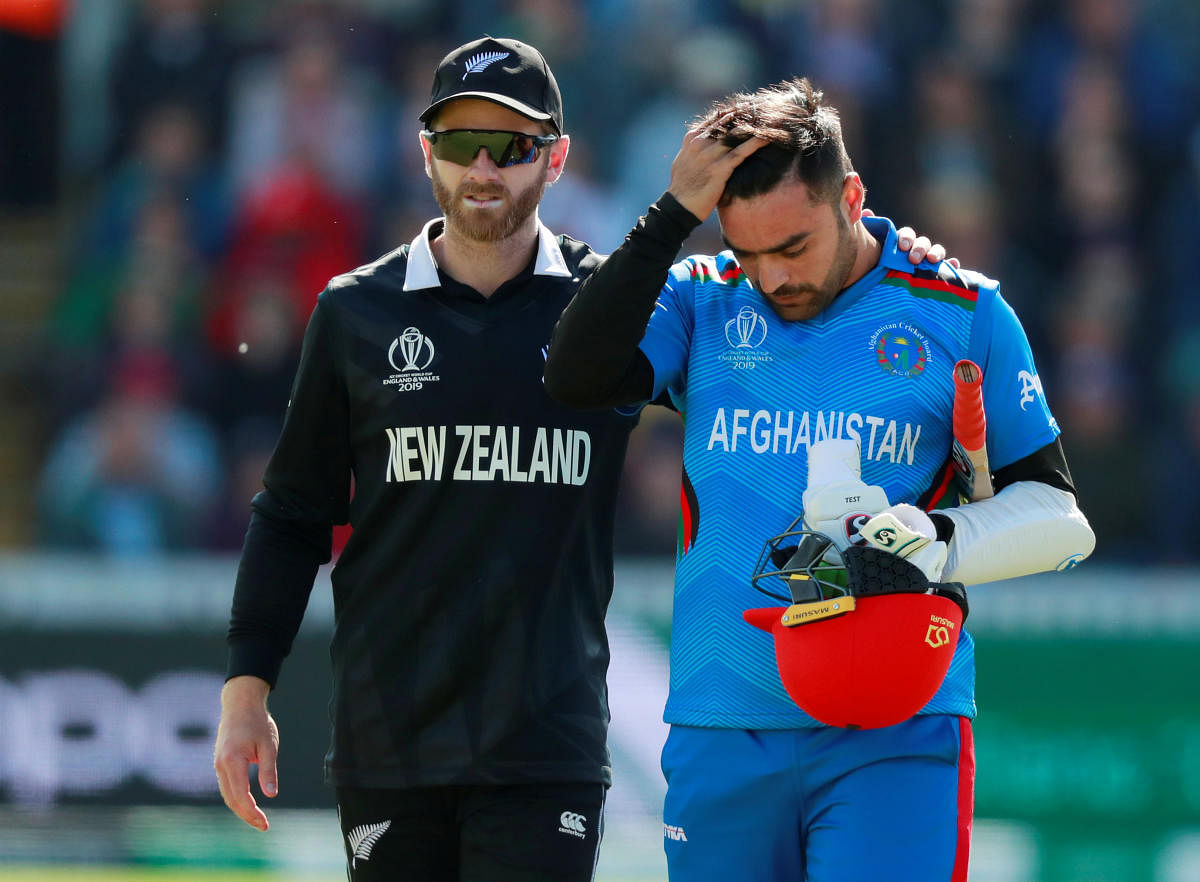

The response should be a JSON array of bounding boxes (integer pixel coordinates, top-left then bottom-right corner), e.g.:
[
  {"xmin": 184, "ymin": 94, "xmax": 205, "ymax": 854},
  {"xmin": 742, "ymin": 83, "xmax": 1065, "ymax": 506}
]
[{"xmin": 215, "ymin": 38, "xmax": 635, "ymax": 882}]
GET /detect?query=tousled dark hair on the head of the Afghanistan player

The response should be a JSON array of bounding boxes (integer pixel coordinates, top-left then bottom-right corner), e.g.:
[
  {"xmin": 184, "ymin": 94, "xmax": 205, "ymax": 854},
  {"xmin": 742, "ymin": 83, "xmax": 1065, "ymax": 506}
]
[{"xmin": 697, "ymin": 78, "xmax": 853, "ymax": 205}]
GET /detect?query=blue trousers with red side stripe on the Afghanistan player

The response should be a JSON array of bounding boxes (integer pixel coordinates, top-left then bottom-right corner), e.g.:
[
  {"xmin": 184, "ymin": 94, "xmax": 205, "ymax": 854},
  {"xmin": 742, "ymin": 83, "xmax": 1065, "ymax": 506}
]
[{"xmin": 662, "ymin": 715, "xmax": 974, "ymax": 882}]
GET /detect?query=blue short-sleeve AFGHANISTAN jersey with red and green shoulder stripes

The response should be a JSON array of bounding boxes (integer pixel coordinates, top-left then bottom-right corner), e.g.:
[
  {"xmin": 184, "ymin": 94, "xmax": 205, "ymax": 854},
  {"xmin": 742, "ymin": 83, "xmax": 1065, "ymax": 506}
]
[{"xmin": 641, "ymin": 218, "xmax": 1058, "ymax": 728}]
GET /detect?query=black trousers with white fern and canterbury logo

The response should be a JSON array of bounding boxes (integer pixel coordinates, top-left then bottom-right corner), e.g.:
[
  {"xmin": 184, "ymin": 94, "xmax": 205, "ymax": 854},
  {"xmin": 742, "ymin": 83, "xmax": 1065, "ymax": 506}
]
[{"xmin": 337, "ymin": 782, "xmax": 606, "ymax": 882}]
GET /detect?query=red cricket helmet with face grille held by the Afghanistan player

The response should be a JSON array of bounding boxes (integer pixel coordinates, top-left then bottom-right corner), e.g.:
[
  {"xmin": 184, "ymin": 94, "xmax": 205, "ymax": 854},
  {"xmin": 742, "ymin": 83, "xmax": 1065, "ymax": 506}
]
[{"xmin": 743, "ymin": 529, "xmax": 967, "ymax": 728}]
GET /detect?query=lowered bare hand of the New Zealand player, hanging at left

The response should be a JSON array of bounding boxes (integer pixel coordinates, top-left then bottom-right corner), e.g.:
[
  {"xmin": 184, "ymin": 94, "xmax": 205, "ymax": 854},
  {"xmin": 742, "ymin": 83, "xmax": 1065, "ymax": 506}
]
[{"xmin": 212, "ymin": 677, "xmax": 280, "ymax": 830}]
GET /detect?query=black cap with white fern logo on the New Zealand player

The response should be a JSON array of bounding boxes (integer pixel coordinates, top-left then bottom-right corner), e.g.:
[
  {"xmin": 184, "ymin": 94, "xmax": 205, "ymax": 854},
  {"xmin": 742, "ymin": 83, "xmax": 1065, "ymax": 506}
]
[{"xmin": 421, "ymin": 37, "xmax": 563, "ymax": 134}]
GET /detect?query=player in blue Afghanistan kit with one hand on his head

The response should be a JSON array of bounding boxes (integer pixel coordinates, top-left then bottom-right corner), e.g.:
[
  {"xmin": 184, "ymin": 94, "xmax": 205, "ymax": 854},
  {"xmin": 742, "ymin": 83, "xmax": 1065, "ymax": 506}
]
[{"xmin": 545, "ymin": 79, "xmax": 1094, "ymax": 882}]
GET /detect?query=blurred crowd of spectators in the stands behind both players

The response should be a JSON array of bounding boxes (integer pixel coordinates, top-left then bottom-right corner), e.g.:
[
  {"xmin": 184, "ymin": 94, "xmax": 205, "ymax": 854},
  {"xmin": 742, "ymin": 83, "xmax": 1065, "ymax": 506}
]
[{"xmin": 0, "ymin": 0, "xmax": 1200, "ymax": 564}]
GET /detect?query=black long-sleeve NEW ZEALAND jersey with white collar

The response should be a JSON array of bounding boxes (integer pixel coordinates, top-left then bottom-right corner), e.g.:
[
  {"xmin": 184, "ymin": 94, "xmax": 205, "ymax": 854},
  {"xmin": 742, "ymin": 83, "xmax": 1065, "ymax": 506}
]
[{"xmin": 228, "ymin": 222, "xmax": 636, "ymax": 787}]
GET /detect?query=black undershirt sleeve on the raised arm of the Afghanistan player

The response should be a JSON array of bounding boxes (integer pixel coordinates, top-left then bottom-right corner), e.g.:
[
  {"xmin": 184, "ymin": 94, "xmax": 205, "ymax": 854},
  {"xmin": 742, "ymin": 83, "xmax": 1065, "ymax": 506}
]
[{"xmin": 546, "ymin": 193, "xmax": 701, "ymax": 407}]
